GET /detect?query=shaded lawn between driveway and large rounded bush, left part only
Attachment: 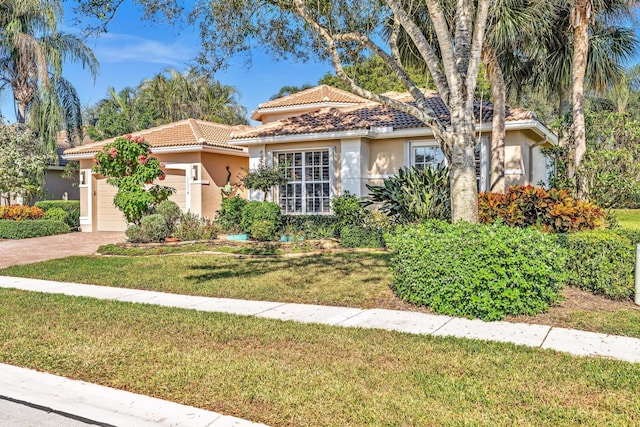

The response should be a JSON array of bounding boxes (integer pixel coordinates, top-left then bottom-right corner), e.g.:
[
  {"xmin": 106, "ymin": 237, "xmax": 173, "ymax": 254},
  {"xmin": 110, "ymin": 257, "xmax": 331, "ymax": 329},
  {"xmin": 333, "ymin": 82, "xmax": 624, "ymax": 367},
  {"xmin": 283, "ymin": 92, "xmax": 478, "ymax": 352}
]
[{"xmin": 0, "ymin": 253, "xmax": 395, "ymax": 308}]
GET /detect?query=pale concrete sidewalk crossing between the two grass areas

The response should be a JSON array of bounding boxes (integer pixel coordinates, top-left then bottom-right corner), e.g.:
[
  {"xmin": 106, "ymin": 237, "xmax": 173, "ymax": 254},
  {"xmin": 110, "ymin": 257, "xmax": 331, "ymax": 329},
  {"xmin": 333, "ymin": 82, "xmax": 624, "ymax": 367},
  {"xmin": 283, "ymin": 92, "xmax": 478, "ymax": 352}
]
[{"xmin": 0, "ymin": 276, "xmax": 640, "ymax": 363}]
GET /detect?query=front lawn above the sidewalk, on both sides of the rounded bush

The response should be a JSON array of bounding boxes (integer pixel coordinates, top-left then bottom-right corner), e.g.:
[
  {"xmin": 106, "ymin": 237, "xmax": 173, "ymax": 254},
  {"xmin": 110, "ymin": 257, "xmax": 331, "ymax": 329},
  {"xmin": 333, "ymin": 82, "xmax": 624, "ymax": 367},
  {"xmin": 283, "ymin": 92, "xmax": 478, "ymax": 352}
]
[{"xmin": 0, "ymin": 252, "xmax": 640, "ymax": 338}]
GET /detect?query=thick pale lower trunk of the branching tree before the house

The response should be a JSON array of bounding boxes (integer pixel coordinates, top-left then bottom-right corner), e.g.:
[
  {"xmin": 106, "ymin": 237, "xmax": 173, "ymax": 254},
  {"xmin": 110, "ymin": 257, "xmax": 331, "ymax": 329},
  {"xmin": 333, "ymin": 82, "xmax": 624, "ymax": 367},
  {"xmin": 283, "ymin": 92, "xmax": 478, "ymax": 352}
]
[{"xmin": 447, "ymin": 105, "xmax": 478, "ymax": 223}]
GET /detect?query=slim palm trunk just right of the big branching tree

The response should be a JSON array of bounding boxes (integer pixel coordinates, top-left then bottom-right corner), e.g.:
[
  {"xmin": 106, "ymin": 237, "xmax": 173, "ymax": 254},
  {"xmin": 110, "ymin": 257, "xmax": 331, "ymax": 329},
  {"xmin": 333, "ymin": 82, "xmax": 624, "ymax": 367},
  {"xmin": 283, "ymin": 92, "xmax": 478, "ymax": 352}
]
[{"xmin": 484, "ymin": 48, "xmax": 507, "ymax": 193}]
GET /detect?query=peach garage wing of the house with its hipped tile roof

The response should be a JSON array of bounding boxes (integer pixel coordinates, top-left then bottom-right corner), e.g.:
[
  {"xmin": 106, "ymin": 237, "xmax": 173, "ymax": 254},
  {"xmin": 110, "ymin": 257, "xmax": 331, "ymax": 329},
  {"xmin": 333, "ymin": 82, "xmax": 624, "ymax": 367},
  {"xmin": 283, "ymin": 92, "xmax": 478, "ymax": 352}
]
[{"xmin": 64, "ymin": 119, "xmax": 248, "ymax": 231}]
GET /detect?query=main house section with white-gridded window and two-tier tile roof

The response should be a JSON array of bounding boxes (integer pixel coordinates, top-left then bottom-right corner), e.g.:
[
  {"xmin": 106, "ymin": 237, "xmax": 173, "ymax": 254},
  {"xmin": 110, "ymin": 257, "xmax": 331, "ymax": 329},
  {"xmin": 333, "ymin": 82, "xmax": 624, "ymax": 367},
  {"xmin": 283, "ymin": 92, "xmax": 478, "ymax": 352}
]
[{"xmin": 229, "ymin": 85, "xmax": 557, "ymax": 214}]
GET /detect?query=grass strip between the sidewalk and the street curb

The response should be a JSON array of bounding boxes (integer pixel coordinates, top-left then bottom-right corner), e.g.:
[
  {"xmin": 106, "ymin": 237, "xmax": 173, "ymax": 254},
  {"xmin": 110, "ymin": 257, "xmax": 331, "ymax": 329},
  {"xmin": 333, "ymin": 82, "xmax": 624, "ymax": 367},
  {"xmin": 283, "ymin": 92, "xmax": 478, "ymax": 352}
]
[{"xmin": 0, "ymin": 289, "xmax": 640, "ymax": 427}]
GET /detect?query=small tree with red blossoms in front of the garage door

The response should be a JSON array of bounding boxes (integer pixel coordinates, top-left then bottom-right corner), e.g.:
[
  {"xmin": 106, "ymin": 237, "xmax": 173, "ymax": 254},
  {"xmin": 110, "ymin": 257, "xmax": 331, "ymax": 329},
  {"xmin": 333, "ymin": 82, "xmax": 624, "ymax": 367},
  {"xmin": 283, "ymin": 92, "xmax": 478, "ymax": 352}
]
[{"xmin": 93, "ymin": 135, "xmax": 175, "ymax": 225}]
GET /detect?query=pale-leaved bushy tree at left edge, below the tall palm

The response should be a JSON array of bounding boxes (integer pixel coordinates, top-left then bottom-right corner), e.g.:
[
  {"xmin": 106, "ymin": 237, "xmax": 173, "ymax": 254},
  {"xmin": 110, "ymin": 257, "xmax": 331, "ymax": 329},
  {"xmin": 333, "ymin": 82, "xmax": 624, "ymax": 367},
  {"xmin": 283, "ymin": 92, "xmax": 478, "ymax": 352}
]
[{"xmin": 0, "ymin": 124, "xmax": 51, "ymax": 204}]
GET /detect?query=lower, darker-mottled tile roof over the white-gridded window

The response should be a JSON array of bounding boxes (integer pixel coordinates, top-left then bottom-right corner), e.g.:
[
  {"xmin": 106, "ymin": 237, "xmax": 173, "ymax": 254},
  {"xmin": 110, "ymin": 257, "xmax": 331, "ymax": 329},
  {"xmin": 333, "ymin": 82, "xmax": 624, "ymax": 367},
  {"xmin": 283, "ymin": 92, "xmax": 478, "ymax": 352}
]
[{"xmin": 232, "ymin": 92, "xmax": 536, "ymax": 139}]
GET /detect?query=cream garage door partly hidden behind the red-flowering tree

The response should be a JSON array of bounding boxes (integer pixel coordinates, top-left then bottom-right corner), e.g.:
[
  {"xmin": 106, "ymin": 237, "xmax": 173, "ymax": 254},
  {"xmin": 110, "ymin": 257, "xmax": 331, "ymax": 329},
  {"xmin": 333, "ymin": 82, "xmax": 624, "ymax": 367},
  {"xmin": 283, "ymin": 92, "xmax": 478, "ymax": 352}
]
[{"xmin": 95, "ymin": 169, "xmax": 187, "ymax": 231}]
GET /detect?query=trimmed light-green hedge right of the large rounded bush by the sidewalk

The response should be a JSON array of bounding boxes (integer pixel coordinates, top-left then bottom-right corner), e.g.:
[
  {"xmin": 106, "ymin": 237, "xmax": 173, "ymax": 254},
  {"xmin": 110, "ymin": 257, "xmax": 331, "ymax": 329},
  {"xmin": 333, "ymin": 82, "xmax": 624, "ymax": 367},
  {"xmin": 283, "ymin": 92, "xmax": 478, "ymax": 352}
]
[{"xmin": 560, "ymin": 230, "xmax": 638, "ymax": 299}]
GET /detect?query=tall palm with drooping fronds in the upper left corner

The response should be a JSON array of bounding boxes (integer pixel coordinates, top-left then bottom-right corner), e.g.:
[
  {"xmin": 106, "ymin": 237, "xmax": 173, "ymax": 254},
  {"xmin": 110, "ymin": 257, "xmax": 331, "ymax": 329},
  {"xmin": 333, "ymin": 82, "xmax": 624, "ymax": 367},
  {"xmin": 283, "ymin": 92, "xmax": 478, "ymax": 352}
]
[{"xmin": 0, "ymin": 0, "xmax": 98, "ymax": 148}]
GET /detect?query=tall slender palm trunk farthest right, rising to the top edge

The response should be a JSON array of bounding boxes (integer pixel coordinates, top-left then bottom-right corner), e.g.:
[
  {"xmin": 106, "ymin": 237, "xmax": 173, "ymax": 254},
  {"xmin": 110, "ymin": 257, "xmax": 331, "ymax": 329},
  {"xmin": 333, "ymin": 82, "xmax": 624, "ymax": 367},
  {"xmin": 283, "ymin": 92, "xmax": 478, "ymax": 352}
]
[{"xmin": 569, "ymin": 0, "xmax": 590, "ymax": 200}]
